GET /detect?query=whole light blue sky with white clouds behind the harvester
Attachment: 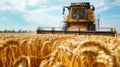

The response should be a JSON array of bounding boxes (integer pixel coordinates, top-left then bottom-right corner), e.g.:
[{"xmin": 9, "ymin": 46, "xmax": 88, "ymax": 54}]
[{"xmin": 0, "ymin": 0, "xmax": 120, "ymax": 33}]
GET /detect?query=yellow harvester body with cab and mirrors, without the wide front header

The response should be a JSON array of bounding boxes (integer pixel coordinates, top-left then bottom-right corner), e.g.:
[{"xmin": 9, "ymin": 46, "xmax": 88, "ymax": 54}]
[{"xmin": 63, "ymin": 2, "xmax": 96, "ymax": 31}]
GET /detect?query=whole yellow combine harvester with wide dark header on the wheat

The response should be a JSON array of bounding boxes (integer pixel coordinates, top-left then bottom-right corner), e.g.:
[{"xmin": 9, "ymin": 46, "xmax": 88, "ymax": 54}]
[{"xmin": 37, "ymin": 2, "xmax": 117, "ymax": 36}]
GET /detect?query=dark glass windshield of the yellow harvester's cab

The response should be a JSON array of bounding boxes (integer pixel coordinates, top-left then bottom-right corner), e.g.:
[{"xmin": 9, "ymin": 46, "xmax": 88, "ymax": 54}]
[{"xmin": 71, "ymin": 7, "xmax": 87, "ymax": 19}]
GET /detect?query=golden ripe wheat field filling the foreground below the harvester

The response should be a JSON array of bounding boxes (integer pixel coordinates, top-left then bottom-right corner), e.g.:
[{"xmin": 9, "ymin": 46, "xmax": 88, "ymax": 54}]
[{"xmin": 0, "ymin": 33, "xmax": 120, "ymax": 67}]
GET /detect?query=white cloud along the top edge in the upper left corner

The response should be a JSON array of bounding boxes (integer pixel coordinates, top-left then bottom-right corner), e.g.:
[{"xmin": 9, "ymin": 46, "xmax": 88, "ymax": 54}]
[{"xmin": 0, "ymin": 0, "xmax": 47, "ymax": 12}]
